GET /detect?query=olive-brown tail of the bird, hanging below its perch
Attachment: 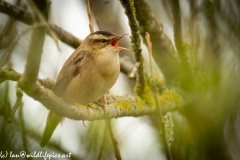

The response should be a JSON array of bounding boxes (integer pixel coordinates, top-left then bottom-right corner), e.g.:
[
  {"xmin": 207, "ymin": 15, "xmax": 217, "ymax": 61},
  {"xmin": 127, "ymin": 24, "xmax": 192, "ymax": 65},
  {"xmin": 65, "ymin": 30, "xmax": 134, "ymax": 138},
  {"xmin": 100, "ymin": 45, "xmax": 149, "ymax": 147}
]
[{"xmin": 40, "ymin": 111, "xmax": 63, "ymax": 147}]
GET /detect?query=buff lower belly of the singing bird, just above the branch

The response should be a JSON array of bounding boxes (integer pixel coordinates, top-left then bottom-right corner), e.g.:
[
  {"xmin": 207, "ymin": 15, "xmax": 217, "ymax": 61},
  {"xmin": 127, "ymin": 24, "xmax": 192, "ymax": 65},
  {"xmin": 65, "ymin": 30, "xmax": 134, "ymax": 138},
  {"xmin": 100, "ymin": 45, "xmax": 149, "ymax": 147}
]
[{"xmin": 62, "ymin": 70, "xmax": 119, "ymax": 105}]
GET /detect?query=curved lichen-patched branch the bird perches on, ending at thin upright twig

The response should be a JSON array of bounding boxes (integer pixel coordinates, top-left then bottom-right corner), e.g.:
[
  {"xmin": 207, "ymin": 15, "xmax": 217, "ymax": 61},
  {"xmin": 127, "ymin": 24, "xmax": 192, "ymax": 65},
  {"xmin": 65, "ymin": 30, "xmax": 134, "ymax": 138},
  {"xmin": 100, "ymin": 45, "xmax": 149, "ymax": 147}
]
[{"xmin": 23, "ymin": 83, "xmax": 155, "ymax": 120}]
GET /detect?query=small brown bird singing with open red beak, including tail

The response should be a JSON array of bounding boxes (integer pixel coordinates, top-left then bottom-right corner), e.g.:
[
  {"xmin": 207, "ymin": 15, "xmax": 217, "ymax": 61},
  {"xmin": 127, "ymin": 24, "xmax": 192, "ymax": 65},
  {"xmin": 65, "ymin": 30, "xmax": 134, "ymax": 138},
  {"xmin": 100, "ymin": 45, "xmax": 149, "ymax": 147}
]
[{"xmin": 40, "ymin": 31, "xmax": 126, "ymax": 147}]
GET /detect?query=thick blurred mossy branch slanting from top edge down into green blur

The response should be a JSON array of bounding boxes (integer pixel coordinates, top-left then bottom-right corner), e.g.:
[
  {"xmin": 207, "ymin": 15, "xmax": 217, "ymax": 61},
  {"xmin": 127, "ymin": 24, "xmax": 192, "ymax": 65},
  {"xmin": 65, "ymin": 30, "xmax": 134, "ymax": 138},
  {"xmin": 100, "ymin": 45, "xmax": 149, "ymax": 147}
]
[{"xmin": 134, "ymin": 0, "xmax": 180, "ymax": 83}]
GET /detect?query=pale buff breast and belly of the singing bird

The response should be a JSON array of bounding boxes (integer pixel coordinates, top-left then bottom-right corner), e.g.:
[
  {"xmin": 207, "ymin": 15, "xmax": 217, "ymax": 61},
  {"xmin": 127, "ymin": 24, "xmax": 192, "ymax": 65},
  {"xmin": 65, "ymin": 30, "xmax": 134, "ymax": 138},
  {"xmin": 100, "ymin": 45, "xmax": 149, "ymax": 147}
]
[{"xmin": 62, "ymin": 55, "xmax": 120, "ymax": 105}]
